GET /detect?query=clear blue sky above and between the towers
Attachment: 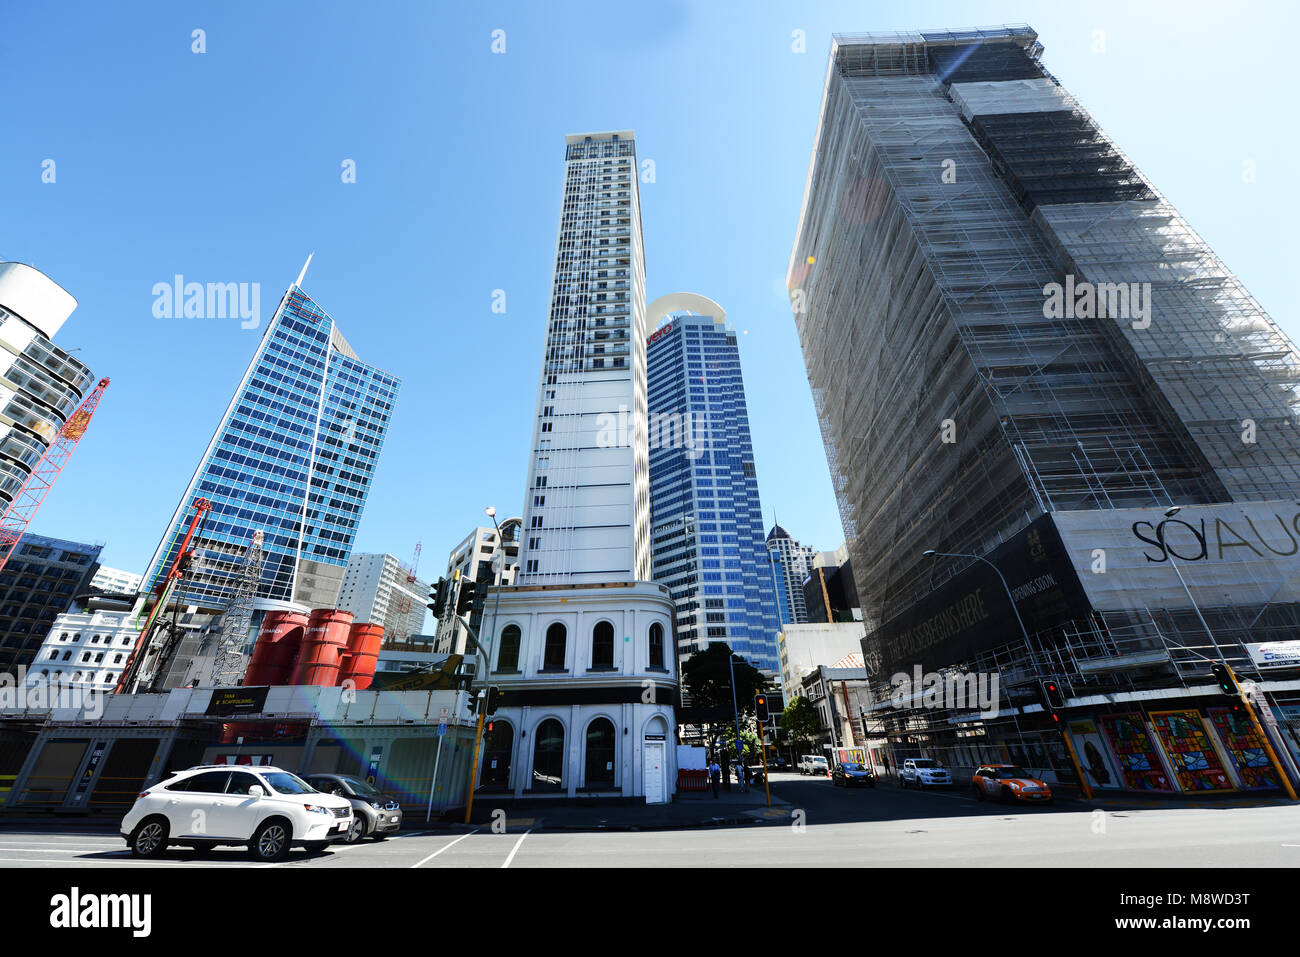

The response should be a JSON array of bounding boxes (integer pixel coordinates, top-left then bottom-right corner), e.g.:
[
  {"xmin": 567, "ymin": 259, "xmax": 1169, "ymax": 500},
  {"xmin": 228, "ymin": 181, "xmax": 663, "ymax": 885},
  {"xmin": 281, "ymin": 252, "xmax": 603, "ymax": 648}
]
[{"xmin": 0, "ymin": 0, "xmax": 1300, "ymax": 573}]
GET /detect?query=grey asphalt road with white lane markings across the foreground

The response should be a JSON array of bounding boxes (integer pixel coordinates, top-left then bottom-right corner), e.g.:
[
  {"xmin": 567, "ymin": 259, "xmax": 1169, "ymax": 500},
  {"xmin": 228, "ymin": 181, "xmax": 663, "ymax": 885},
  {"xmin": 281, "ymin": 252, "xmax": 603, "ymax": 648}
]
[{"xmin": 0, "ymin": 774, "xmax": 1300, "ymax": 869}]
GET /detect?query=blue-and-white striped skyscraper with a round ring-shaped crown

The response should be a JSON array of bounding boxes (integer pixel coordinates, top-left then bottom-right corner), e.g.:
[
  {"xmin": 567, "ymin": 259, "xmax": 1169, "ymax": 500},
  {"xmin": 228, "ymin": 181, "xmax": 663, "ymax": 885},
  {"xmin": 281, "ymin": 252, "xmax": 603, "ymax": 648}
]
[{"xmin": 647, "ymin": 293, "xmax": 780, "ymax": 676}]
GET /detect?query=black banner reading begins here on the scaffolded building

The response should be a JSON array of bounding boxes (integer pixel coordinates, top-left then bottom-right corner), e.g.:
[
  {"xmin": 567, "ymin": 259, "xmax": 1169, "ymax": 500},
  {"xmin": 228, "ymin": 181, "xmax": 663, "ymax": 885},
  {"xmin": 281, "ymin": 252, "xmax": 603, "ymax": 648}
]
[{"xmin": 862, "ymin": 515, "xmax": 1088, "ymax": 675}]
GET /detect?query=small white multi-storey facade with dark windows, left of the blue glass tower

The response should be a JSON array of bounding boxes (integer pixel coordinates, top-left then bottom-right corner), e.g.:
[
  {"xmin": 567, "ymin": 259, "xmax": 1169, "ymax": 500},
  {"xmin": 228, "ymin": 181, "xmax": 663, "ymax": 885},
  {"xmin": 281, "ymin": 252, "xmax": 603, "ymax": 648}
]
[{"xmin": 26, "ymin": 611, "xmax": 140, "ymax": 692}]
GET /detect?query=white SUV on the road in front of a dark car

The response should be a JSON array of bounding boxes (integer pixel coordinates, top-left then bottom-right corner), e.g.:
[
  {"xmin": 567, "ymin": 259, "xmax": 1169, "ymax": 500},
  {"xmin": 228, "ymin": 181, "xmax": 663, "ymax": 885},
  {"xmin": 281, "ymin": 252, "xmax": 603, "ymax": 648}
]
[{"xmin": 118, "ymin": 765, "xmax": 352, "ymax": 861}]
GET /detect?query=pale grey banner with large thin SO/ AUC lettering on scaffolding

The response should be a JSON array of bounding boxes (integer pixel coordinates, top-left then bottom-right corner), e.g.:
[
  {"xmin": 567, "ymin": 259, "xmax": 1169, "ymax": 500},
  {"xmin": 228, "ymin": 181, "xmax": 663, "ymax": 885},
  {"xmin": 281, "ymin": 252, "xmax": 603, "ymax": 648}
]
[{"xmin": 1053, "ymin": 502, "xmax": 1300, "ymax": 611}]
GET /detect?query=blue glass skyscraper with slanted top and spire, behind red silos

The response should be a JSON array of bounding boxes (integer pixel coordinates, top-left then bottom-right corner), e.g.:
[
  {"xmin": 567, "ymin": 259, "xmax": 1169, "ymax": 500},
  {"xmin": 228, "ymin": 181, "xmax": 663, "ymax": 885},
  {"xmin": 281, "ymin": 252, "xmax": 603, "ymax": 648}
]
[{"xmin": 144, "ymin": 268, "xmax": 400, "ymax": 610}]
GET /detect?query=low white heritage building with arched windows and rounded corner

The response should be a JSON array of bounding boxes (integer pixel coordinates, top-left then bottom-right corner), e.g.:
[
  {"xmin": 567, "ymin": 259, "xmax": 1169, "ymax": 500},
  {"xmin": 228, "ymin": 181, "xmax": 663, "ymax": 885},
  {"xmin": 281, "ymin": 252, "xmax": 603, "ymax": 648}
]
[{"xmin": 480, "ymin": 581, "xmax": 677, "ymax": 804}]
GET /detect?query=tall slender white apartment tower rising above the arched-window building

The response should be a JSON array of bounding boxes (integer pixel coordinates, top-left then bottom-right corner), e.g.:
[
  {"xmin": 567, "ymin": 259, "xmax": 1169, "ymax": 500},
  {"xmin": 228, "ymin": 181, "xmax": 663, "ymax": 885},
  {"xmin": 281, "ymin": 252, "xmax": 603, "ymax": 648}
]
[{"xmin": 519, "ymin": 131, "xmax": 650, "ymax": 585}]
